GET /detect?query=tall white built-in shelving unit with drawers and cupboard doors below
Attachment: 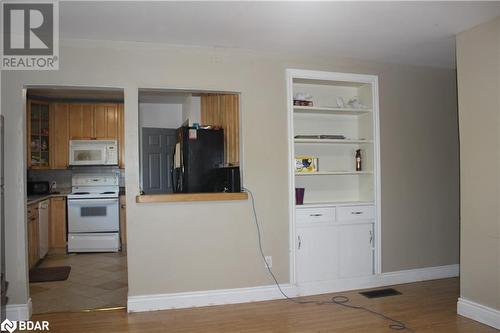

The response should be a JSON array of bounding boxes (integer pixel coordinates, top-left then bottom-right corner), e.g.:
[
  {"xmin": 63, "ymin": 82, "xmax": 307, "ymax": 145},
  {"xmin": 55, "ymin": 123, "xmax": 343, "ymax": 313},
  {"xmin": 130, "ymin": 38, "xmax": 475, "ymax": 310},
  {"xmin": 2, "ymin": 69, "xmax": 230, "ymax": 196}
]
[{"xmin": 287, "ymin": 69, "xmax": 380, "ymax": 294}]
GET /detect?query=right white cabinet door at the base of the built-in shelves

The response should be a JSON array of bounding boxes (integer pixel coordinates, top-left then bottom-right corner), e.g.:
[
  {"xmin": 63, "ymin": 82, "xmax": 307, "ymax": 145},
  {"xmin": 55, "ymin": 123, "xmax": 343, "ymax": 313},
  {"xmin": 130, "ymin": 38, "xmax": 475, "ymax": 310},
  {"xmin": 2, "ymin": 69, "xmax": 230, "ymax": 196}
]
[{"xmin": 338, "ymin": 223, "xmax": 374, "ymax": 278}]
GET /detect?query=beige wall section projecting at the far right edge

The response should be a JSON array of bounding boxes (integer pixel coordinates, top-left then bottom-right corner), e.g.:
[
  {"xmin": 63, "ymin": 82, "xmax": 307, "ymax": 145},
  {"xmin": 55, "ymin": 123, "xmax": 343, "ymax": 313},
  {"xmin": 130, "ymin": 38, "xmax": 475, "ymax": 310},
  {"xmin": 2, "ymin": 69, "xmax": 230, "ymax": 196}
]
[{"xmin": 457, "ymin": 19, "xmax": 500, "ymax": 310}]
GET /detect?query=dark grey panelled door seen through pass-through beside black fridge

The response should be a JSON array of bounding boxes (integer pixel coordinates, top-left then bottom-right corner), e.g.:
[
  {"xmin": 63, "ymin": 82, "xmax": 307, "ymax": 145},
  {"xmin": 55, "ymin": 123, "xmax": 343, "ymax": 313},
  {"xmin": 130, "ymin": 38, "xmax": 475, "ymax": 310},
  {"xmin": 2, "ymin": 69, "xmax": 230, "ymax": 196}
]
[{"xmin": 142, "ymin": 128, "xmax": 176, "ymax": 194}]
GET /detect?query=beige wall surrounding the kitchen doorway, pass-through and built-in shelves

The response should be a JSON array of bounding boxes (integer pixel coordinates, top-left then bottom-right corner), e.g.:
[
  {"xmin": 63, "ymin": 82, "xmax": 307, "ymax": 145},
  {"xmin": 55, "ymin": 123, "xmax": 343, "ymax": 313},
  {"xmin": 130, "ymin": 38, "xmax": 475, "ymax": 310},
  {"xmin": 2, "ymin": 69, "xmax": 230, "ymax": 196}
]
[{"xmin": 2, "ymin": 41, "xmax": 458, "ymax": 303}]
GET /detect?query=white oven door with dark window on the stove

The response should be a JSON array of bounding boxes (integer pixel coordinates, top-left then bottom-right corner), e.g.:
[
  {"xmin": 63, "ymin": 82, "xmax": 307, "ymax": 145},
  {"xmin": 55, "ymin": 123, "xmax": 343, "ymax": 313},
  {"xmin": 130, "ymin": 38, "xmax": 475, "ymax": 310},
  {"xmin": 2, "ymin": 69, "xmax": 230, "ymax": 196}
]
[{"xmin": 68, "ymin": 198, "xmax": 120, "ymax": 233}]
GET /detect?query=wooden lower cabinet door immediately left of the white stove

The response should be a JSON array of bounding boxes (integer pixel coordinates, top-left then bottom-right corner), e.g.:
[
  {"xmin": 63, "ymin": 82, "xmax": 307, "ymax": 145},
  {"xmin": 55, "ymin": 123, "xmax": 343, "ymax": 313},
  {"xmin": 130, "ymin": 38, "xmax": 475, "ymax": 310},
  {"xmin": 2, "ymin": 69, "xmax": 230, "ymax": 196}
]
[{"xmin": 49, "ymin": 197, "xmax": 67, "ymax": 253}]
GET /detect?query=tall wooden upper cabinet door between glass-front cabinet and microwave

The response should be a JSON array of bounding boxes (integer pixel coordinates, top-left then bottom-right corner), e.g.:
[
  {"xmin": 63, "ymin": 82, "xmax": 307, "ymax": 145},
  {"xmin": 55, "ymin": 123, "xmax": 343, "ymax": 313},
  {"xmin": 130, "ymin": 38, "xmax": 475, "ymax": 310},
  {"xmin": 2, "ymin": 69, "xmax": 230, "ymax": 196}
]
[{"xmin": 50, "ymin": 103, "xmax": 70, "ymax": 169}]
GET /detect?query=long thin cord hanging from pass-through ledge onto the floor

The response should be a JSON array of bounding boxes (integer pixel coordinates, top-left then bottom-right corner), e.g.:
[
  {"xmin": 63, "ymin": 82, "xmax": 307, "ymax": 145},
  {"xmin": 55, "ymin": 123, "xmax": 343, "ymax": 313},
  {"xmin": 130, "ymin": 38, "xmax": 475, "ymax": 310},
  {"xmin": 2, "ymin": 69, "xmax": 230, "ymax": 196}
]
[{"xmin": 243, "ymin": 188, "xmax": 415, "ymax": 333}]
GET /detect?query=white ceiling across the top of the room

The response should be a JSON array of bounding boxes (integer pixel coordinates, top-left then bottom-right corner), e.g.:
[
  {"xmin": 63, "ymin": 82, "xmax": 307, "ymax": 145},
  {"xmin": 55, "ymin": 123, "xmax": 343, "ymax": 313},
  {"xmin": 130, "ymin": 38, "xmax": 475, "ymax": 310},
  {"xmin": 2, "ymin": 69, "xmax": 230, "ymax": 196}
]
[{"xmin": 60, "ymin": 1, "xmax": 500, "ymax": 68}]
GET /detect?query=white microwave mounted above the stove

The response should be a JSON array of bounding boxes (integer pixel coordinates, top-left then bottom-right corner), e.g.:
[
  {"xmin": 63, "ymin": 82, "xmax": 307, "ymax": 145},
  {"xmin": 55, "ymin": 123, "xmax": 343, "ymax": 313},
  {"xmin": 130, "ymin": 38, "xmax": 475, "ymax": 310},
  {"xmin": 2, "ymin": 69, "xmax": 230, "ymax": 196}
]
[{"xmin": 69, "ymin": 140, "xmax": 118, "ymax": 165}]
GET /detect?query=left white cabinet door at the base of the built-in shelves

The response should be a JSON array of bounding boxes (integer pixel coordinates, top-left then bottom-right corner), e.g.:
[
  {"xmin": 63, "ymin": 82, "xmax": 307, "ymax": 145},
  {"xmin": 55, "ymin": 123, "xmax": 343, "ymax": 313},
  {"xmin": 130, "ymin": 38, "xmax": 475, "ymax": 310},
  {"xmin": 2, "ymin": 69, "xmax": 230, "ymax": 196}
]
[{"xmin": 296, "ymin": 226, "xmax": 339, "ymax": 283}]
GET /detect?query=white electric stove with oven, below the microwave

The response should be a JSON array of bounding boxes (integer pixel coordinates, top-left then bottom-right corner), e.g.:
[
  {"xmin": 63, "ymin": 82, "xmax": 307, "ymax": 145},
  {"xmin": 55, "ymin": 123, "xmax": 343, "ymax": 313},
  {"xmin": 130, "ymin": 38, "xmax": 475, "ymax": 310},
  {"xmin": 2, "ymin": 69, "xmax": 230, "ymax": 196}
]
[{"xmin": 68, "ymin": 173, "xmax": 120, "ymax": 252}]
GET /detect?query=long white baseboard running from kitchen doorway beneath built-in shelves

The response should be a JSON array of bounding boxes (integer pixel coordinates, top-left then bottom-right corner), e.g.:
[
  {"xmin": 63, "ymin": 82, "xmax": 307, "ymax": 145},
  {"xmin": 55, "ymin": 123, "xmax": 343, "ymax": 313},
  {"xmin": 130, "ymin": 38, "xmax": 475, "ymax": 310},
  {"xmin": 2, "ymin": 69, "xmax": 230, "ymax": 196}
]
[{"xmin": 127, "ymin": 265, "xmax": 459, "ymax": 312}]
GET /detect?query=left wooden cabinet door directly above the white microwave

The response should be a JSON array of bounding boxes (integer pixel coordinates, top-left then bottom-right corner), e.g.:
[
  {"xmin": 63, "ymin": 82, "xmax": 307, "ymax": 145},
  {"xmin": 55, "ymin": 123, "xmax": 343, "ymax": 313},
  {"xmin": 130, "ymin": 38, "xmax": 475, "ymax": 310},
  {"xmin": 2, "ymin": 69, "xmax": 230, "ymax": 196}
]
[{"xmin": 69, "ymin": 103, "xmax": 94, "ymax": 140}]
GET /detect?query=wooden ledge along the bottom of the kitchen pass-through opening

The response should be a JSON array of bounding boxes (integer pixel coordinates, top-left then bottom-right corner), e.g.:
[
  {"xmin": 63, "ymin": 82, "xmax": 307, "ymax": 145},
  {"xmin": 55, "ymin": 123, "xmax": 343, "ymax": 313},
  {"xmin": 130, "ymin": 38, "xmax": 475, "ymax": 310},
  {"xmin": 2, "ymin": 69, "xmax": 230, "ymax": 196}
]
[{"xmin": 135, "ymin": 192, "xmax": 248, "ymax": 203}]
